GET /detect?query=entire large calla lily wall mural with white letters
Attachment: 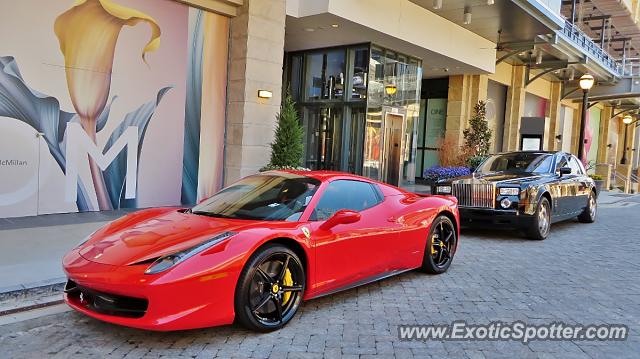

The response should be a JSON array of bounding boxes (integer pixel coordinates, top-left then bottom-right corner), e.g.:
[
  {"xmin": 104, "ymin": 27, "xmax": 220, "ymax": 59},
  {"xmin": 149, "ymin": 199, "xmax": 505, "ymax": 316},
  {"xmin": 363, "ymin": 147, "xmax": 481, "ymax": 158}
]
[{"xmin": 0, "ymin": 0, "xmax": 228, "ymax": 217}]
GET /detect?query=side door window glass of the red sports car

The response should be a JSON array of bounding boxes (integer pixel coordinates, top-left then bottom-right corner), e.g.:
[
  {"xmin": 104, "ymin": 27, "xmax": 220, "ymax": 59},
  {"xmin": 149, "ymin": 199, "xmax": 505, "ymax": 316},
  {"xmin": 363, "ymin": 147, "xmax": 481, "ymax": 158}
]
[{"xmin": 311, "ymin": 180, "xmax": 381, "ymax": 221}]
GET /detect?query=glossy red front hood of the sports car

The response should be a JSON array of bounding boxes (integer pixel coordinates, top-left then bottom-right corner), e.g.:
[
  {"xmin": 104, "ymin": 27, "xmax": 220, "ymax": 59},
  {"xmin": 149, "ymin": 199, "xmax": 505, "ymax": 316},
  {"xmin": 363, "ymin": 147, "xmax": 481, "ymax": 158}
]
[{"xmin": 80, "ymin": 208, "xmax": 250, "ymax": 265}]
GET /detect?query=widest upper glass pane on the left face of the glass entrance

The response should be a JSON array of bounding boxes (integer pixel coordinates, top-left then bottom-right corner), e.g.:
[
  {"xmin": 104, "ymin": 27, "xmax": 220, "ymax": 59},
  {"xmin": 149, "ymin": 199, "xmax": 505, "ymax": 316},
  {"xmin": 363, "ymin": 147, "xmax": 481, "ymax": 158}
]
[{"xmin": 305, "ymin": 50, "xmax": 345, "ymax": 101}]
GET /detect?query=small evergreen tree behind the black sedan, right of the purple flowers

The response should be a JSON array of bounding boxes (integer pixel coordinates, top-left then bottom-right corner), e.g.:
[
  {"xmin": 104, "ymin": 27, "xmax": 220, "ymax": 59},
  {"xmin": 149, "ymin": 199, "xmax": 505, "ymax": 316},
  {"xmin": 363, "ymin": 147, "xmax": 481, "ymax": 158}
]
[{"xmin": 463, "ymin": 101, "xmax": 491, "ymax": 169}]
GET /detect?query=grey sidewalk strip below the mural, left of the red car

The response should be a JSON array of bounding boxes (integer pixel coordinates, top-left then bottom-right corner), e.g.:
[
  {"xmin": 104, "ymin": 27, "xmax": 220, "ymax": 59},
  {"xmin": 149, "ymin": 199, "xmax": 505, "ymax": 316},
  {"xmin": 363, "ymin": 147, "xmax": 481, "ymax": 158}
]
[{"xmin": 0, "ymin": 209, "xmax": 132, "ymax": 294}]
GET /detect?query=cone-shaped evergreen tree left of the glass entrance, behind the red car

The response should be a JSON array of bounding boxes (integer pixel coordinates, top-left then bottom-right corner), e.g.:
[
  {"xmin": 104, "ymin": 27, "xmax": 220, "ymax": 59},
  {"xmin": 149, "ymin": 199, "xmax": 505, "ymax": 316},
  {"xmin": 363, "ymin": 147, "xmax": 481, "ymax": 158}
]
[{"xmin": 261, "ymin": 91, "xmax": 304, "ymax": 171}]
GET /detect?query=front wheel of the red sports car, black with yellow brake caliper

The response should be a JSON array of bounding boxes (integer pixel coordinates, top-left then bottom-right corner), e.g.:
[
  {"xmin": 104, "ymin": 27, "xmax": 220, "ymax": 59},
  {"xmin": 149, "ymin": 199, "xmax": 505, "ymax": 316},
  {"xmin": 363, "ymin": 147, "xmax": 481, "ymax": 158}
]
[{"xmin": 235, "ymin": 244, "xmax": 306, "ymax": 332}]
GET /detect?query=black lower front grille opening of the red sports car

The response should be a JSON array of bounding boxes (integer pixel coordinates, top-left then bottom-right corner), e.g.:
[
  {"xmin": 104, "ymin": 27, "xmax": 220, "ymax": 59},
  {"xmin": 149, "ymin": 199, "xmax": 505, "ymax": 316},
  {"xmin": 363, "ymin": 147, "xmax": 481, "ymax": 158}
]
[{"xmin": 64, "ymin": 280, "xmax": 149, "ymax": 318}]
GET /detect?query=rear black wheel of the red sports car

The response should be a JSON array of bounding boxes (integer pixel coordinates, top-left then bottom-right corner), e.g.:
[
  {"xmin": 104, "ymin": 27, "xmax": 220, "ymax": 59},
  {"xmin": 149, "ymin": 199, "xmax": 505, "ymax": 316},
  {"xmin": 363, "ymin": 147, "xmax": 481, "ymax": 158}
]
[{"xmin": 420, "ymin": 215, "xmax": 458, "ymax": 274}]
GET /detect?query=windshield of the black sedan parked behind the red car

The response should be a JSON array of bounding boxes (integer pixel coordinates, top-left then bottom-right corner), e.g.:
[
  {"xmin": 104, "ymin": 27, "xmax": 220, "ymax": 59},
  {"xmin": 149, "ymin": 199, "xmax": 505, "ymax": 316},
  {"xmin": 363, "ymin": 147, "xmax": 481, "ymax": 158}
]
[{"xmin": 475, "ymin": 152, "xmax": 553, "ymax": 174}]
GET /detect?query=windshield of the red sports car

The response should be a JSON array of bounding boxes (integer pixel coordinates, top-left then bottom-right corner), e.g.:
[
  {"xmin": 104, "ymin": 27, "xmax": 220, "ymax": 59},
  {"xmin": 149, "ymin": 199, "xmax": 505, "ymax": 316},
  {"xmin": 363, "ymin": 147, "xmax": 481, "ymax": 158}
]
[{"xmin": 191, "ymin": 173, "xmax": 320, "ymax": 221}]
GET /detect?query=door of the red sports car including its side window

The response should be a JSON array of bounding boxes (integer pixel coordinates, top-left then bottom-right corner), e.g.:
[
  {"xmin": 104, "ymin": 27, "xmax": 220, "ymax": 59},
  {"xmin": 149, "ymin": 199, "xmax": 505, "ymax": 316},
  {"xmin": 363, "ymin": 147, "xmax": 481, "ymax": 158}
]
[{"xmin": 310, "ymin": 180, "xmax": 398, "ymax": 293}]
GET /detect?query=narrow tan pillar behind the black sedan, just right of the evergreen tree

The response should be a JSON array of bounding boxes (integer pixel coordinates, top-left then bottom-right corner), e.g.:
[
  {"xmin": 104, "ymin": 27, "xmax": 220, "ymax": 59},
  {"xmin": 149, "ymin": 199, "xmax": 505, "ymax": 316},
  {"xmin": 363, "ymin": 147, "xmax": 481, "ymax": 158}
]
[{"xmin": 502, "ymin": 65, "xmax": 526, "ymax": 151}]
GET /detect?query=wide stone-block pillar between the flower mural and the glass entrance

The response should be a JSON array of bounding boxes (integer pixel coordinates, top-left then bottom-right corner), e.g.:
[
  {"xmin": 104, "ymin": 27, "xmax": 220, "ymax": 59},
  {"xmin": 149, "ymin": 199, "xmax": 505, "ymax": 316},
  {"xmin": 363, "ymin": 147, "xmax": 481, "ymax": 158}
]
[{"xmin": 224, "ymin": 0, "xmax": 286, "ymax": 184}]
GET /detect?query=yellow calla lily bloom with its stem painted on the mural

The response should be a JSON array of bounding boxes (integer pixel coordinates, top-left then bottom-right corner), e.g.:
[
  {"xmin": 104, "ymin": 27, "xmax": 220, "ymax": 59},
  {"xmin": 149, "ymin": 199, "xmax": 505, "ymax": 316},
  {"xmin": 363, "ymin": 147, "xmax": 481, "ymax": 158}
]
[{"xmin": 54, "ymin": 0, "xmax": 160, "ymax": 210}]
